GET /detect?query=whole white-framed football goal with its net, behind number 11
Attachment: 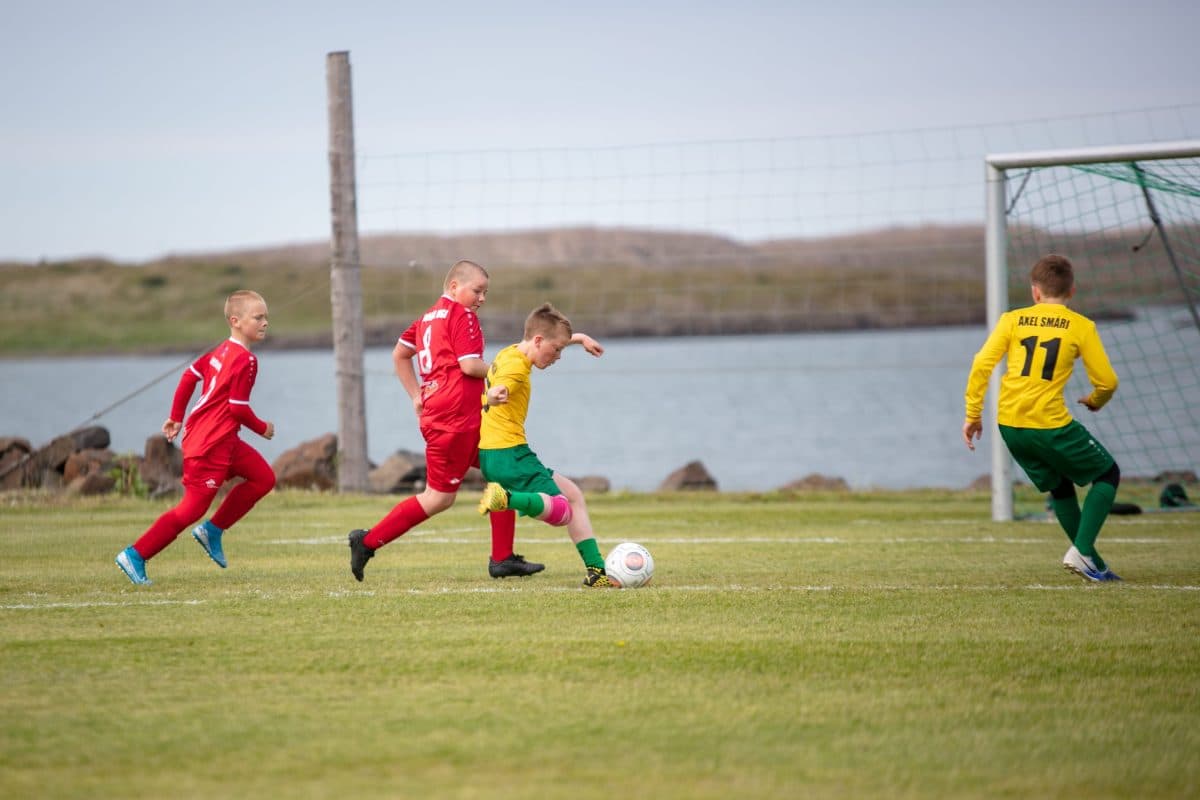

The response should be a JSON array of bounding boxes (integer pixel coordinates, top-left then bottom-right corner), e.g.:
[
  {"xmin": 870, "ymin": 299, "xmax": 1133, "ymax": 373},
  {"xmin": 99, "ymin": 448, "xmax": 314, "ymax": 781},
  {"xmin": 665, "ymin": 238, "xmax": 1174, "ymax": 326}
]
[{"xmin": 985, "ymin": 140, "xmax": 1200, "ymax": 521}]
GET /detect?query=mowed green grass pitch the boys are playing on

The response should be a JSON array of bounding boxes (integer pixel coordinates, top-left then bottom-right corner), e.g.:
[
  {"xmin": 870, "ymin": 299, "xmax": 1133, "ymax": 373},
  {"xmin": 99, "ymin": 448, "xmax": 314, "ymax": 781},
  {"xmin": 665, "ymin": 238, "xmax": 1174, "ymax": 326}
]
[{"xmin": 0, "ymin": 492, "xmax": 1200, "ymax": 799}]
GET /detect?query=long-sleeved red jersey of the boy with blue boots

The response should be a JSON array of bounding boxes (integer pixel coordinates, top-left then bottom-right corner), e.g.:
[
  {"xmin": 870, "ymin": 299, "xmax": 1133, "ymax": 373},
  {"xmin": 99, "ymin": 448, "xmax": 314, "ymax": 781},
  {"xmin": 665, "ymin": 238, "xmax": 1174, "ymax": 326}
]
[{"xmin": 170, "ymin": 338, "xmax": 266, "ymax": 458}]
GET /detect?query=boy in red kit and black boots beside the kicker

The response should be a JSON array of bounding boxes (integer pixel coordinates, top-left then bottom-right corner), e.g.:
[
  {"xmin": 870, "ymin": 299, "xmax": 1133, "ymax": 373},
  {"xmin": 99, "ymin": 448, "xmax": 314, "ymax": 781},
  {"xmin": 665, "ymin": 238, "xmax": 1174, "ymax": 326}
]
[{"xmin": 348, "ymin": 260, "xmax": 545, "ymax": 581}]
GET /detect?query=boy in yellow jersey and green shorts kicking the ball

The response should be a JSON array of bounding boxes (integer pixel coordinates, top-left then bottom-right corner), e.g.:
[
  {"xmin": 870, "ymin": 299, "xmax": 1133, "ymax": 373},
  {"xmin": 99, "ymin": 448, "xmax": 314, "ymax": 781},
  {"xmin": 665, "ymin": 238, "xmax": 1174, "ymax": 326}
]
[{"xmin": 479, "ymin": 302, "xmax": 613, "ymax": 588}]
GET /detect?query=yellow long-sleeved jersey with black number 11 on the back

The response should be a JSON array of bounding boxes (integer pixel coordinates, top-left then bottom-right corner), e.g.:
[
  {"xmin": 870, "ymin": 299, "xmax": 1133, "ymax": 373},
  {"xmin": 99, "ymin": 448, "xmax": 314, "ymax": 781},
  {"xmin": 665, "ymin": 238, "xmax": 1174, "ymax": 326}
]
[{"xmin": 964, "ymin": 302, "xmax": 1117, "ymax": 429}]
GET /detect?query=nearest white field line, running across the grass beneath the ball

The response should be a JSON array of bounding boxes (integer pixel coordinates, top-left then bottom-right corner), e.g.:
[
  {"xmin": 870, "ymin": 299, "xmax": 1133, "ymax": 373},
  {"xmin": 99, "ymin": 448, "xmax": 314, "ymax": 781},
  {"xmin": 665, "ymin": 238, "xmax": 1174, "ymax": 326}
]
[{"xmin": 0, "ymin": 582, "xmax": 1200, "ymax": 610}]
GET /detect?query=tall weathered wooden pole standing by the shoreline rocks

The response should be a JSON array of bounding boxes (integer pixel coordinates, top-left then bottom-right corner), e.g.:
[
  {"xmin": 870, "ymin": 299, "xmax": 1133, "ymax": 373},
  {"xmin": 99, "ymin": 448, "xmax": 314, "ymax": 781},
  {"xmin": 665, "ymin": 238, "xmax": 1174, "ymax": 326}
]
[{"xmin": 325, "ymin": 50, "xmax": 367, "ymax": 492}]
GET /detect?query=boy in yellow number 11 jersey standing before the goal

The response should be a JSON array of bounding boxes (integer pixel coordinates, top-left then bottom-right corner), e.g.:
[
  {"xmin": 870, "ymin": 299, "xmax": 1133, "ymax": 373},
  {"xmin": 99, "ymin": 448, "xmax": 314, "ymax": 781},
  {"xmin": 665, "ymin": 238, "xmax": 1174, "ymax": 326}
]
[{"xmin": 962, "ymin": 255, "xmax": 1121, "ymax": 581}]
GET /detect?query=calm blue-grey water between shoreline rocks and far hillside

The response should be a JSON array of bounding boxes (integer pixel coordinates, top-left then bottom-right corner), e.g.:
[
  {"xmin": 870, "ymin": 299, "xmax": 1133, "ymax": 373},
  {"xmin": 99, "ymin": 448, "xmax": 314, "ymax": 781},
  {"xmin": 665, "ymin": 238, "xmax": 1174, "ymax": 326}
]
[{"xmin": 0, "ymin": 316, "xmax": 1200, "ymax": 492}]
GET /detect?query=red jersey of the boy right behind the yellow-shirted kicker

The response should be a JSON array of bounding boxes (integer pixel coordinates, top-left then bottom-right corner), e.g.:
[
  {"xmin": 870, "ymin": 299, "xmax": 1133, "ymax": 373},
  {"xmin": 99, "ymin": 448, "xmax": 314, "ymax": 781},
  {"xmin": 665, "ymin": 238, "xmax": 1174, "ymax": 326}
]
[{"xmin": 400, "ymin": 295, "xmax": 484, "ymax": 433}]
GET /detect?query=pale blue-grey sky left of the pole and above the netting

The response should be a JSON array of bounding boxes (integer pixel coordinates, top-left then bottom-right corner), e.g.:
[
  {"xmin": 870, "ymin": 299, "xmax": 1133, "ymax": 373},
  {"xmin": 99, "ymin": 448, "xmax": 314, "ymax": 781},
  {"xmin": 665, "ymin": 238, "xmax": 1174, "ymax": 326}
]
[{"xmin": 0, "ymin": 0, "xmax": 1200, "ymax": 263}]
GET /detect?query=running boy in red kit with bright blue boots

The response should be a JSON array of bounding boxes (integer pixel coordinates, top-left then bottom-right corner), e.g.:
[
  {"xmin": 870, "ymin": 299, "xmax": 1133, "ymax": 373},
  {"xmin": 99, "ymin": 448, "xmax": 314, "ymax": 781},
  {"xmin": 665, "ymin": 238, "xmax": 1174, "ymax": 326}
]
[{"xmin": 116, "ymin": 290, "xmax": 275, "ymax": 584}]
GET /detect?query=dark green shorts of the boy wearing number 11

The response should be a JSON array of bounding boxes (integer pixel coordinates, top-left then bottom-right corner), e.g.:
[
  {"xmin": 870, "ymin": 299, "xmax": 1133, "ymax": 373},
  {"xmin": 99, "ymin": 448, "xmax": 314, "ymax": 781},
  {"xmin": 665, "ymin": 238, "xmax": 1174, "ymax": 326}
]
[{"xmin": 1000, "ymin": 420, "xmax": 1114, "ymax": 492}]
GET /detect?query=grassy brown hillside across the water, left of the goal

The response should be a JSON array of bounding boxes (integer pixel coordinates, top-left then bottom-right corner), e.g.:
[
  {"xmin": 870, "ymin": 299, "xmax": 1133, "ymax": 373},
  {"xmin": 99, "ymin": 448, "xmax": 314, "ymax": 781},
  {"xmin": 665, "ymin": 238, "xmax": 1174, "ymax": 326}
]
[{"xmin": 0, "ymin": 221, "xmax": 984, "ymax": 356}]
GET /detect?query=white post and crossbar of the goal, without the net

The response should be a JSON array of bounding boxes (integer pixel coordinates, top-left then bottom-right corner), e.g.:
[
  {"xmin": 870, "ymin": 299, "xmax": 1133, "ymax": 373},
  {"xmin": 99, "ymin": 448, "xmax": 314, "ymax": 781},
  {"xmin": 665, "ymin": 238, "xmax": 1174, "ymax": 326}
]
[{"xmin": 985, "ymin": 140, "xmax": 1200, "ymax": 522}]
